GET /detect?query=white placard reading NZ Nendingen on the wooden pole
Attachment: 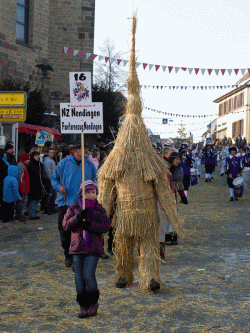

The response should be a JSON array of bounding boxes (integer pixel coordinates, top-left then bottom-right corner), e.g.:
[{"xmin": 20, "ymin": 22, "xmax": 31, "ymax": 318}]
[{"xmin": 60, "ymin": 103, "xmax": 103, "ymax": 134}]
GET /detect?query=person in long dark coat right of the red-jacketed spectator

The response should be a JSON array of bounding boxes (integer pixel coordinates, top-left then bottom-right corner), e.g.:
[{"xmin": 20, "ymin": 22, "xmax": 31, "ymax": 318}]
[{"xmin": 28, "ymin": 151, "xmax": 43, "ymax": 220}]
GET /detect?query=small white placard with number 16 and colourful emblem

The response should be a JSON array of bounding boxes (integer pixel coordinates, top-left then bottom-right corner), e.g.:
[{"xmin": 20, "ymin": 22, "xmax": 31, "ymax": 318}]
[{"xmin": 69, "ymin": 72, "xmax": 92, "ymax": 103}]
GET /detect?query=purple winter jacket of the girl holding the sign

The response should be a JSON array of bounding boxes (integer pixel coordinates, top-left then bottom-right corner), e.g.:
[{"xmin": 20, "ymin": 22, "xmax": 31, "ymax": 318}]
[{"xmin": 62, "ymin": 201, "xmax": 110, "ymax": 255}]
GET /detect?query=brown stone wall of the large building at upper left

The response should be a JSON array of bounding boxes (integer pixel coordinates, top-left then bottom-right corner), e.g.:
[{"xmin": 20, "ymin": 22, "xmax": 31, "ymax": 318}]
[{"xmin": 0, "ymin": 0, "xmax": 95, "ymax": 100}]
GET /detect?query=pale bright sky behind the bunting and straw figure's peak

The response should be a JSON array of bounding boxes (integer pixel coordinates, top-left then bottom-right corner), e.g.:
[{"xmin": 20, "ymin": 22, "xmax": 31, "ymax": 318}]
[{"xmin": 94, "ymin": 0, "xmax": 250, "ymax": 140}]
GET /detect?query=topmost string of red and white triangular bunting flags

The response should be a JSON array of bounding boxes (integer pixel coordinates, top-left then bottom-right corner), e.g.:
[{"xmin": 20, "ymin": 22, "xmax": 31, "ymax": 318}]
[{"xmin": 62, "ymin": 46, "xmax": 250, "ymax": 76}]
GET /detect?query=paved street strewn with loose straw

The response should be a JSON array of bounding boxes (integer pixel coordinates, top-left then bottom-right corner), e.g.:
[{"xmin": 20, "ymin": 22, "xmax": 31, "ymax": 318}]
[{"xmin": 0, "ymin": 167, "xmax": 250, "ymax": 333}]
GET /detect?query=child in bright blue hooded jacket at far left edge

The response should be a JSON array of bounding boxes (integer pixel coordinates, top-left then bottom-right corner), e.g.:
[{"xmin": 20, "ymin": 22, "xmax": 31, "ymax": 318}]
[{"xmin": 3, "ymin": 165, "xmax": 22, "ymax": 222}]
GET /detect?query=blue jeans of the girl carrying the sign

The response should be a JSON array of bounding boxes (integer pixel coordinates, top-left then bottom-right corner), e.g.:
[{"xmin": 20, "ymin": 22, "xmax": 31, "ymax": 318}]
[{"xmin": 72, "ymin": 254, "xmax": 99, "ymax": 294}]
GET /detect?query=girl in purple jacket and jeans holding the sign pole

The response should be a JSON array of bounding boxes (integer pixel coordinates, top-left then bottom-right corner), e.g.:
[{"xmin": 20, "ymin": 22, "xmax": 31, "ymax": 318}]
[{"xmin": 62, "ymin": 180, "xmax": 110, "ymax": 318}]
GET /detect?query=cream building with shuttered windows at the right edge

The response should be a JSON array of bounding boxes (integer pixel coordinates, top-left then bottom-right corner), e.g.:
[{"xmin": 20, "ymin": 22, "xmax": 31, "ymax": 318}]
[{"xmin": 203, "ymin": 73, "xmax": 250, "ymax": 144}]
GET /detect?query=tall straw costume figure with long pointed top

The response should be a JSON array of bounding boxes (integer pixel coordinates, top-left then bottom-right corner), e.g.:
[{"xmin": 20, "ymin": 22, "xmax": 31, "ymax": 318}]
[{"xmin": 98, "ymin": 16, "xmax": 184, "ymax": 291}]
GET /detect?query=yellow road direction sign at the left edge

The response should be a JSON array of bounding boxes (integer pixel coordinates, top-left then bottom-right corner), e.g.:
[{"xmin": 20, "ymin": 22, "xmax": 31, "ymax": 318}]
[{"xmin": 0, "ymin": 91, "xmax": 27, "ymax": 122}]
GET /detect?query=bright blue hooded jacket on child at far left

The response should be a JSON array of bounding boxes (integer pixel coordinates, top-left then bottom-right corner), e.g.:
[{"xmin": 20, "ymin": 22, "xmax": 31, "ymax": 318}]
[{"xmin": 3, "ymin": 165, "xmax": 21, "ymax": 203}]
